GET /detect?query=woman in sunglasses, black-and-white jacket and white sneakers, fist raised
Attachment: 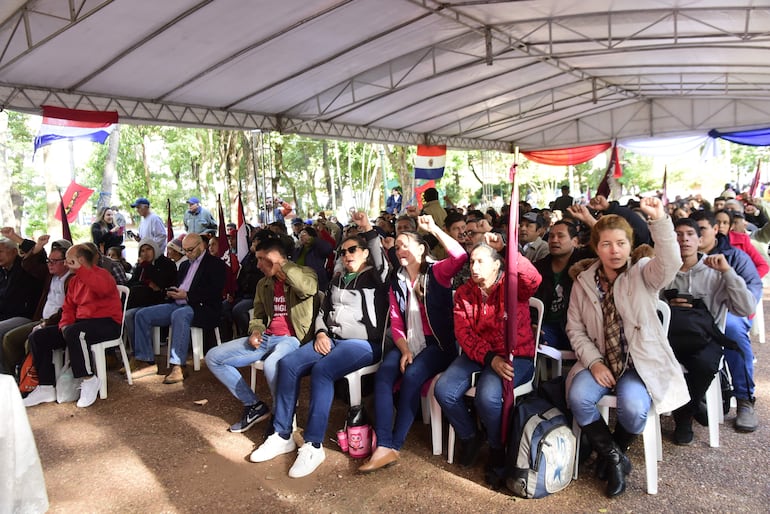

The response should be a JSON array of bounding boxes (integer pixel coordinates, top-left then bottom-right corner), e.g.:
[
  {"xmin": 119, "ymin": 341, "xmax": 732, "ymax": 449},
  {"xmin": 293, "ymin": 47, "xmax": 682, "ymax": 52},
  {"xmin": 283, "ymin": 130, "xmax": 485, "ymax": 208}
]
[{"xmin": 251, "ymin": 208, "xmax": 390, "ymax": 478}]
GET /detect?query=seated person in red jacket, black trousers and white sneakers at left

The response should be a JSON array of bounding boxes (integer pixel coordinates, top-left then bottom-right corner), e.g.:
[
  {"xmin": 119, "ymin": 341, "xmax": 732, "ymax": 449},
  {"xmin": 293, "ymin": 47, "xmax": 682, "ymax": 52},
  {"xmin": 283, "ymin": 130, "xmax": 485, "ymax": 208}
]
[{"xmin": 24, "ymin": 244, "xmax": 123, "ymax": 407}]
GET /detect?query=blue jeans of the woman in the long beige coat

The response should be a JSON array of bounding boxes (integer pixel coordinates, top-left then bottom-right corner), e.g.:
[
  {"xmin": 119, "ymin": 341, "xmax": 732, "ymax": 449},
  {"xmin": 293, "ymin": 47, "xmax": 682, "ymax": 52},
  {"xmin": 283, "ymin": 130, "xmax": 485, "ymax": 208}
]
[{"xmin": 567, "ymin": 369, "xmax": 652, "ymax": 434}]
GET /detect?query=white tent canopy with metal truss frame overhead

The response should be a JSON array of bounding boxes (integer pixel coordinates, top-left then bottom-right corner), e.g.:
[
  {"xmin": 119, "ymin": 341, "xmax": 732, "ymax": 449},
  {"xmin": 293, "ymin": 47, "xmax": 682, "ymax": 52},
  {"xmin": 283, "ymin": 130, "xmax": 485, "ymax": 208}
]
[{"xmin": 0, "ymin": 0, "xmax": 770, "ymax": 151}]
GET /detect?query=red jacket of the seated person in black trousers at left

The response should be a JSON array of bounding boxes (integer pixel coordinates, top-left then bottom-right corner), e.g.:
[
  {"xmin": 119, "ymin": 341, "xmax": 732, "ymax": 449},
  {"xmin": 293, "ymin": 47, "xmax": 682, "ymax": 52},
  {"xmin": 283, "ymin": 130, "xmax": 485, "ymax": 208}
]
[{"xmin": 59, "ymin": 266, "xmax": 123, "ymax": 328}]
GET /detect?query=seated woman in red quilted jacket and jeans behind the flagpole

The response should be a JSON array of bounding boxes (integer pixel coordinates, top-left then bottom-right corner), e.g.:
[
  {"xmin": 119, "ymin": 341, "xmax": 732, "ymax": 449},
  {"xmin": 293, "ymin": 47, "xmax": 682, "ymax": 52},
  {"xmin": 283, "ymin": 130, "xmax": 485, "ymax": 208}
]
[{"xmin": 435, "ymin": 243, "xmax": 542, "ymax": 485}]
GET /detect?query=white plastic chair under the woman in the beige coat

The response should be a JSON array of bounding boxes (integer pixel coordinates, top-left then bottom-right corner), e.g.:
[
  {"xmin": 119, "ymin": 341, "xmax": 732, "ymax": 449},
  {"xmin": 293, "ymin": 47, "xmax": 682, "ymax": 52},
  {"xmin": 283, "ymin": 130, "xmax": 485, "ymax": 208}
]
[{"xmin": 572, "ymin": 300, "xmax": 671, "ymax": 494}]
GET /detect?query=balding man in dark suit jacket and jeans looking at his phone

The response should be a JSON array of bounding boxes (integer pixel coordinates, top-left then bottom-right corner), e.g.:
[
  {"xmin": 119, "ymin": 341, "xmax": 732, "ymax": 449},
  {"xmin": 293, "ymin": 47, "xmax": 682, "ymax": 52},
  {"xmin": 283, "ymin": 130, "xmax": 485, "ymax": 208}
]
[{"xmin": 132, "ymin": 234, "xmax": 226, "ymax": 384}]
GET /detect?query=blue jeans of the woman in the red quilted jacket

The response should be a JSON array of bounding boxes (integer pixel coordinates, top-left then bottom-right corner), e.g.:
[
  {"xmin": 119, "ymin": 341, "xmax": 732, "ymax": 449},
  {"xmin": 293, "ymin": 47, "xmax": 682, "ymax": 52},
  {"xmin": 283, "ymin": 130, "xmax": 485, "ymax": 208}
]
[{"xmin": 434, "ymin": 354, "xmax": 535, "ymax": 448}]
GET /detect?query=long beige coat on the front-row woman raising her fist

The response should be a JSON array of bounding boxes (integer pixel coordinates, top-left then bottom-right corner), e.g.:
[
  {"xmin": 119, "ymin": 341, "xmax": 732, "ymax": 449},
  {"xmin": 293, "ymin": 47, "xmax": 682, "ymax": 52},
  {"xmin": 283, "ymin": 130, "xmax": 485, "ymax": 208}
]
[{"xmin": 567, "ymin": 217, "xmax": 690, "ymax": 413}]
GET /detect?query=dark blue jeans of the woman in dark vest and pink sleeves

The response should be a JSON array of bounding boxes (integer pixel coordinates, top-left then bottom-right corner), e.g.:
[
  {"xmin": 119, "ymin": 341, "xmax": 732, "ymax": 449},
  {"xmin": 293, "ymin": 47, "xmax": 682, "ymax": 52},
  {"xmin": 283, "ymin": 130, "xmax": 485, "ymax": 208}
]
[{"xmin": 374, "ymin": 337, "xmax": 454, "ymax": 450}]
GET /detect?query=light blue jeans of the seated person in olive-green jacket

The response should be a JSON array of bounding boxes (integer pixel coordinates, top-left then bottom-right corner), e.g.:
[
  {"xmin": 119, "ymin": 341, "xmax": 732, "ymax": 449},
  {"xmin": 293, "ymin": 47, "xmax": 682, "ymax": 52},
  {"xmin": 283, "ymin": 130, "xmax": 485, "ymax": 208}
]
[{"xmin": 206, "ymin": 334, "xmax": 299, "ymax": 405}]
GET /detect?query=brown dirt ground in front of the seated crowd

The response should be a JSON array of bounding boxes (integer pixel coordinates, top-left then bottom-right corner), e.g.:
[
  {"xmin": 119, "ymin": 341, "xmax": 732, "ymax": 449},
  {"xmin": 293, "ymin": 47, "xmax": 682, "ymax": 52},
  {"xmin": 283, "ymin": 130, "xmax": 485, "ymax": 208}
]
[{"xmin": 22, "ymin": 298, "xmax": 770, "ymax": 513}]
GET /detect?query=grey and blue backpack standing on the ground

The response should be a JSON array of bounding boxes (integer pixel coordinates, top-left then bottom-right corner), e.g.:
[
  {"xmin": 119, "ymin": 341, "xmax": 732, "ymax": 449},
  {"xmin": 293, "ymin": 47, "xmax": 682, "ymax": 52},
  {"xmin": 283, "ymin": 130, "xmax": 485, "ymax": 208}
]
[{"xmin": 505, "ymin": 396, "xmax": 576, "ymax": 498}]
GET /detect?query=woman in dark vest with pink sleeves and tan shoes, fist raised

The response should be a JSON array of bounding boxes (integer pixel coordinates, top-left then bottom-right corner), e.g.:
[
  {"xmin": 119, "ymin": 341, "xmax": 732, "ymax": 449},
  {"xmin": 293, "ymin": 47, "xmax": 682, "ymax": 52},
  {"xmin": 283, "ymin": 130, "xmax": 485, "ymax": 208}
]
[{"xmin": 359, "ymin": 215, "xmax": 468, "ymax": 473}]
